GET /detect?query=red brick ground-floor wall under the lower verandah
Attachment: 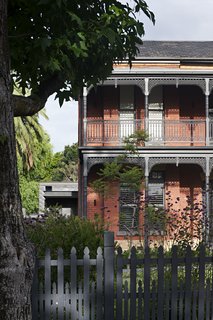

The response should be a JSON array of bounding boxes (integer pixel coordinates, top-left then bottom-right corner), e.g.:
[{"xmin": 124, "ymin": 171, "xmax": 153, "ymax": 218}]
[{"xmin": 87, "ymin": 164, "xmax": 203, "ymax": 241}]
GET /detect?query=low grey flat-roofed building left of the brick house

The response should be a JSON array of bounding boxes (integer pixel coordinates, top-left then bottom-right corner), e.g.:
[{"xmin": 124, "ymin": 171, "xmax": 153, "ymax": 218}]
[{"xmin": 39, "ymin": 182, "xmax": 78, "ymax": 215}]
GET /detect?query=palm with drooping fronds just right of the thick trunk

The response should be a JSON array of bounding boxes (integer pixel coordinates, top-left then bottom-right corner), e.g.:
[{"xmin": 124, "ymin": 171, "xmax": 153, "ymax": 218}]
[{"xmin": 14, "ymin": 110, "xmax": 53, "ymax": 213}]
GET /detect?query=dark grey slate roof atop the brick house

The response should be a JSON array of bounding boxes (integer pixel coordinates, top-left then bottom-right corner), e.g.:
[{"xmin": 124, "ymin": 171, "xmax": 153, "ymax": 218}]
[{"xmin": 137, "ymin": 41, "xmax": 213, "ymax": 60}]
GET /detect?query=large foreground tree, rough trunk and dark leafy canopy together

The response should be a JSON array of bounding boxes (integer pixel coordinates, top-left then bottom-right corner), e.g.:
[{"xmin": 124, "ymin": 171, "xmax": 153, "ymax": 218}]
[{"xmin": 0, "ymin": 0, "xmax": 154, "ymax": 320}]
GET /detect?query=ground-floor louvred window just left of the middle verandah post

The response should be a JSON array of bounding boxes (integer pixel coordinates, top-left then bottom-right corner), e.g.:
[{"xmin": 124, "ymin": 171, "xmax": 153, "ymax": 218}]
[{"xmin": 119, "ymin": 184, "xmax": 138, "ymax": 232}]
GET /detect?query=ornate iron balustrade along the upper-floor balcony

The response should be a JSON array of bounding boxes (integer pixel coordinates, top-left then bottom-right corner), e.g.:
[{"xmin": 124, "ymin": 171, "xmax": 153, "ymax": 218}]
[{"xmin": 84, "ymin": 119, "xmax": 213, "ymax": 146}]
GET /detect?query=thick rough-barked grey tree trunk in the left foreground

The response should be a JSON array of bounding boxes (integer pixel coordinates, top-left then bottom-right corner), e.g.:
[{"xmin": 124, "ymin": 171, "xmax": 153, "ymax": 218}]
[{"xmin": 0, "ymin": 0, "xmax": 33, "ymax": 320}]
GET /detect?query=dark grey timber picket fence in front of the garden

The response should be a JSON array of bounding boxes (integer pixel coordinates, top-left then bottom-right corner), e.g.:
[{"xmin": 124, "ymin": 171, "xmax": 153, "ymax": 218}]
[{"xmin": 32, "ymin": 232, "xmax": 213, "ymax": 320}]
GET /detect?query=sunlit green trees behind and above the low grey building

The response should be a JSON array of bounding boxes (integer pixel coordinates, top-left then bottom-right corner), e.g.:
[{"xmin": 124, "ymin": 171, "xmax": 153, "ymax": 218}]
[{"xmin": 18, "ymin": 141, "xmax": 78, "ymax": 214}]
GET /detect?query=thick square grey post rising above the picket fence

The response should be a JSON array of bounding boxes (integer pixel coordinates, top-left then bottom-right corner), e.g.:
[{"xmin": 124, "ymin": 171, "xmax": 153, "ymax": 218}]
[{"xmin": 104, "ymin": 231, "xmax": 114, "ymax": 320}]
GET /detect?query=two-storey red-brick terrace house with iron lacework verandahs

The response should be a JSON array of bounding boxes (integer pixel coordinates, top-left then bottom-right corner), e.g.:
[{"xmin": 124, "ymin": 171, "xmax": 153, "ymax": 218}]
[{"xmin": 79, "ymin": 41, "xmax": 213, "ymax": 246}]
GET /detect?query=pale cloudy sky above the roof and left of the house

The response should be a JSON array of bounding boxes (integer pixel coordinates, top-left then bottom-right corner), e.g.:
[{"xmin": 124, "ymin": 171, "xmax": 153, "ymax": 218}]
[{"xmin": 40, "ymin": 0, "xmax": 213, "ymax": 152}]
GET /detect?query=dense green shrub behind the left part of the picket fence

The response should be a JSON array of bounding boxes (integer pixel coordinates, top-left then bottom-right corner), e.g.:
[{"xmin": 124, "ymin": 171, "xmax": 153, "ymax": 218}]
[{"xmin": 26, "ymin": 210, "xmax": 104, "ymax": 259}]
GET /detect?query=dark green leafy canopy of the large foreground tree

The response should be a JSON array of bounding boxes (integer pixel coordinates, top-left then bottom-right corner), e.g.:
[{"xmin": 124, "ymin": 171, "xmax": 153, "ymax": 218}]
[{"xmin": 8, "ymin": 0, "xmax": 154, "ymax": 115}]
